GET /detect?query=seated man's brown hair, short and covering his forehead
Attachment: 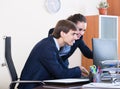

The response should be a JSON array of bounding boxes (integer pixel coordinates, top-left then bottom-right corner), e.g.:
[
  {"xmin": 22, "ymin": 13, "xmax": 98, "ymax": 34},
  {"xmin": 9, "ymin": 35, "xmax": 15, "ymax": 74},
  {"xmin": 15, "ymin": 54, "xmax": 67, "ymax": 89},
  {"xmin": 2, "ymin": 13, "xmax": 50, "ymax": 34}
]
[{"xmin": 52, "ymin": 20, "xmax": 77, "ymax": 38}]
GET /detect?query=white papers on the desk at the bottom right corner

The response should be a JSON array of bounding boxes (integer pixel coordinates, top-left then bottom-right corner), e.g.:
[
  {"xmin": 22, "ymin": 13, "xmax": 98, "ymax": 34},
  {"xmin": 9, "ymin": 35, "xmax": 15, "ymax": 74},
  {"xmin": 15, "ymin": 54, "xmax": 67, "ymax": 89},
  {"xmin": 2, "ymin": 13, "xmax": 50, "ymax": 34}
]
[{"xmin": 82, "ymin": 83, "xmax": 120, "ymax": 89}]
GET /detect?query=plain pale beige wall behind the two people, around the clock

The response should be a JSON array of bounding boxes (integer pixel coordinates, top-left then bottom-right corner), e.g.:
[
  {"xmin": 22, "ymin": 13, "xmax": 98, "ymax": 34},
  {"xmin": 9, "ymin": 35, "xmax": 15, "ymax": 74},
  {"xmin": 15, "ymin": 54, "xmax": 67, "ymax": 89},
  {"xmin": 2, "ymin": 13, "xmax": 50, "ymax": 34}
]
[{"xmin": 0, "ymin": 0, "xmax": 98, "ymax": 89}]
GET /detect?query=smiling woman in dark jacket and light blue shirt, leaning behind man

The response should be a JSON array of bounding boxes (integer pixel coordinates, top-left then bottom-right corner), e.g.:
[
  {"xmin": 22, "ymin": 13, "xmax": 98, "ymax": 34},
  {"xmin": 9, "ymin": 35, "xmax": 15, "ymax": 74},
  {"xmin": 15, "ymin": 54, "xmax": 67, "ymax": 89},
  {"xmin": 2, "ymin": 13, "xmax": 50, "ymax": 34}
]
[{"xmin": 48, "ymin": 13, "xmax": 93, "ymax": 67}]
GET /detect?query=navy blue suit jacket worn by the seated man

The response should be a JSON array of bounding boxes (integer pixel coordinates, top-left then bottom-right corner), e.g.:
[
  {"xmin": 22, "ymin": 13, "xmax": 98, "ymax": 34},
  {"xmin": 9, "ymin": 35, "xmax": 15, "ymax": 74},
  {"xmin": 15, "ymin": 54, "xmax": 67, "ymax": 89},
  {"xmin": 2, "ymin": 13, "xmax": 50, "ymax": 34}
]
[{"xmin": 18, "ymin": 36, "xmax": 81, "ymax": 89}]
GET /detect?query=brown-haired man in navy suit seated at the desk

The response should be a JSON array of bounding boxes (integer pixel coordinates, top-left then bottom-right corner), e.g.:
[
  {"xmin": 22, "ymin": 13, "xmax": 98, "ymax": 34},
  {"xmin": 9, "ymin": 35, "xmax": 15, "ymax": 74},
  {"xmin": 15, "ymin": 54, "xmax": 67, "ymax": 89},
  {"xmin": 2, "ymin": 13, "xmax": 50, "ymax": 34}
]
[{"xmin": 18, "ymin": 20, "xmax": 88, "ymax": 89}]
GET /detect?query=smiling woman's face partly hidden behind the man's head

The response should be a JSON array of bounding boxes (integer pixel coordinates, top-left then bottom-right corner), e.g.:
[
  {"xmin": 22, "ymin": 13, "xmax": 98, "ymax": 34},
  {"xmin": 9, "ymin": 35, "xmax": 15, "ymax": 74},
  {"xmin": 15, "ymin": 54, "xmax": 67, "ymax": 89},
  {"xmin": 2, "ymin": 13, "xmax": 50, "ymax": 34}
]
[{"xmin": 76, "ymin": 21, "xmax": 87, "ymax": 39}]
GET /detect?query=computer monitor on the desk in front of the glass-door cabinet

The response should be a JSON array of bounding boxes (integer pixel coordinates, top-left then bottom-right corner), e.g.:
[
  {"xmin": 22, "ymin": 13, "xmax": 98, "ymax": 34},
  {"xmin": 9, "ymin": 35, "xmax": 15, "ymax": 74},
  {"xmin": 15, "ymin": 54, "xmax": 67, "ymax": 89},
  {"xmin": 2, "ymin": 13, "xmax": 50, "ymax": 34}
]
[{"xmin": 92, "ymin": 38, "xmax": 117, "ymax": 68}]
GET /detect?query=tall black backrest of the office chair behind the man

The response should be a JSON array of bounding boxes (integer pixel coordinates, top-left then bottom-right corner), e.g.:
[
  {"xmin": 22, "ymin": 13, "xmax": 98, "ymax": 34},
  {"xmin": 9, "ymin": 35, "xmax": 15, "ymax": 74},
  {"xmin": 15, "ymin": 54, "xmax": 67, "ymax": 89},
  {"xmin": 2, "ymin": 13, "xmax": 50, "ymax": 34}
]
[{"xmin": 5, "ymin": 36, "xmax": 18, "ymax": 81}]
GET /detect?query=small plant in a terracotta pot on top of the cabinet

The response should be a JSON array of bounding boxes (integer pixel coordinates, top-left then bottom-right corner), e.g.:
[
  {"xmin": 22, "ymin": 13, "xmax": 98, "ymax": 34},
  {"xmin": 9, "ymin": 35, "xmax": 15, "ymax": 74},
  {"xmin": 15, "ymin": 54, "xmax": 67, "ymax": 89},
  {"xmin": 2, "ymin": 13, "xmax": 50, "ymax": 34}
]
[{"xmin": 98, "ymin": 0, "xmax": 109, "ymax": 15}]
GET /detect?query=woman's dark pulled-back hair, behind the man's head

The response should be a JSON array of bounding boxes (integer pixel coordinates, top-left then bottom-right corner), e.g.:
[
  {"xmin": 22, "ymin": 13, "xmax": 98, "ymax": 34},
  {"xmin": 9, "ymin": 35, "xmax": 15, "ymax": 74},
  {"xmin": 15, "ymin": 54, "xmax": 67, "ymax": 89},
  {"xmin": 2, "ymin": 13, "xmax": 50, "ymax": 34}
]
[{"xmin": 67, "ymin": 14, "xmax": 87, "ymax": 24}]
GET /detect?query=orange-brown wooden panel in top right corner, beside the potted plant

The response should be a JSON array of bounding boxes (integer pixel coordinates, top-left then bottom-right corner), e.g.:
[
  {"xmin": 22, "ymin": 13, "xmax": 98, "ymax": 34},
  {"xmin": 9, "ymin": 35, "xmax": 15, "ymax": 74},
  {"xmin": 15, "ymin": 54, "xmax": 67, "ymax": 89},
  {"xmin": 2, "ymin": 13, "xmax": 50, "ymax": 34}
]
[{"xmin": 107, "ymin": 0, "xmax": 120, "ymax": 16}]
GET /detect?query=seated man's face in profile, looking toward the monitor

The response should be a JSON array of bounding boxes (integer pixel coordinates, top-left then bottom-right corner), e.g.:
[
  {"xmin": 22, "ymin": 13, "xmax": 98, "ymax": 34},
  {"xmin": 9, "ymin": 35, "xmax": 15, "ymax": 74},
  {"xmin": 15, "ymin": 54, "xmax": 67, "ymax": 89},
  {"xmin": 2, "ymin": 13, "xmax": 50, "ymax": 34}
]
[{"xmin": 62, "ymin": 30, "xmax": 78, "ymax": 46}]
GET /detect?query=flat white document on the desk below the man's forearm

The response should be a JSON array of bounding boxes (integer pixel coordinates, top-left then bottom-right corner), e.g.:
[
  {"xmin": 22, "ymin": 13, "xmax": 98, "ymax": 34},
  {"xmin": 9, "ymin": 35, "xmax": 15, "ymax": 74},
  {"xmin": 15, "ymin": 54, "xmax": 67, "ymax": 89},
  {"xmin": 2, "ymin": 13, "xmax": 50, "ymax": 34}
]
[{"xmin": 43, "ymin": 78, "xmax": 89, "ymax": 84}]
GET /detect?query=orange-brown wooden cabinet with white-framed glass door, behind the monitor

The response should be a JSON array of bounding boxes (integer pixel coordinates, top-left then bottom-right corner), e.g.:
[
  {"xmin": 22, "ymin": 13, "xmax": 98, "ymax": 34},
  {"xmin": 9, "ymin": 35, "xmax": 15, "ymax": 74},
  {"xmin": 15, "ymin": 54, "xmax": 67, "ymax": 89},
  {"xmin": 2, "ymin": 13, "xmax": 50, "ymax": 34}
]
[{"xmin": 82, "ymin": 15, "xmax": 120, "ymax": 70}]
